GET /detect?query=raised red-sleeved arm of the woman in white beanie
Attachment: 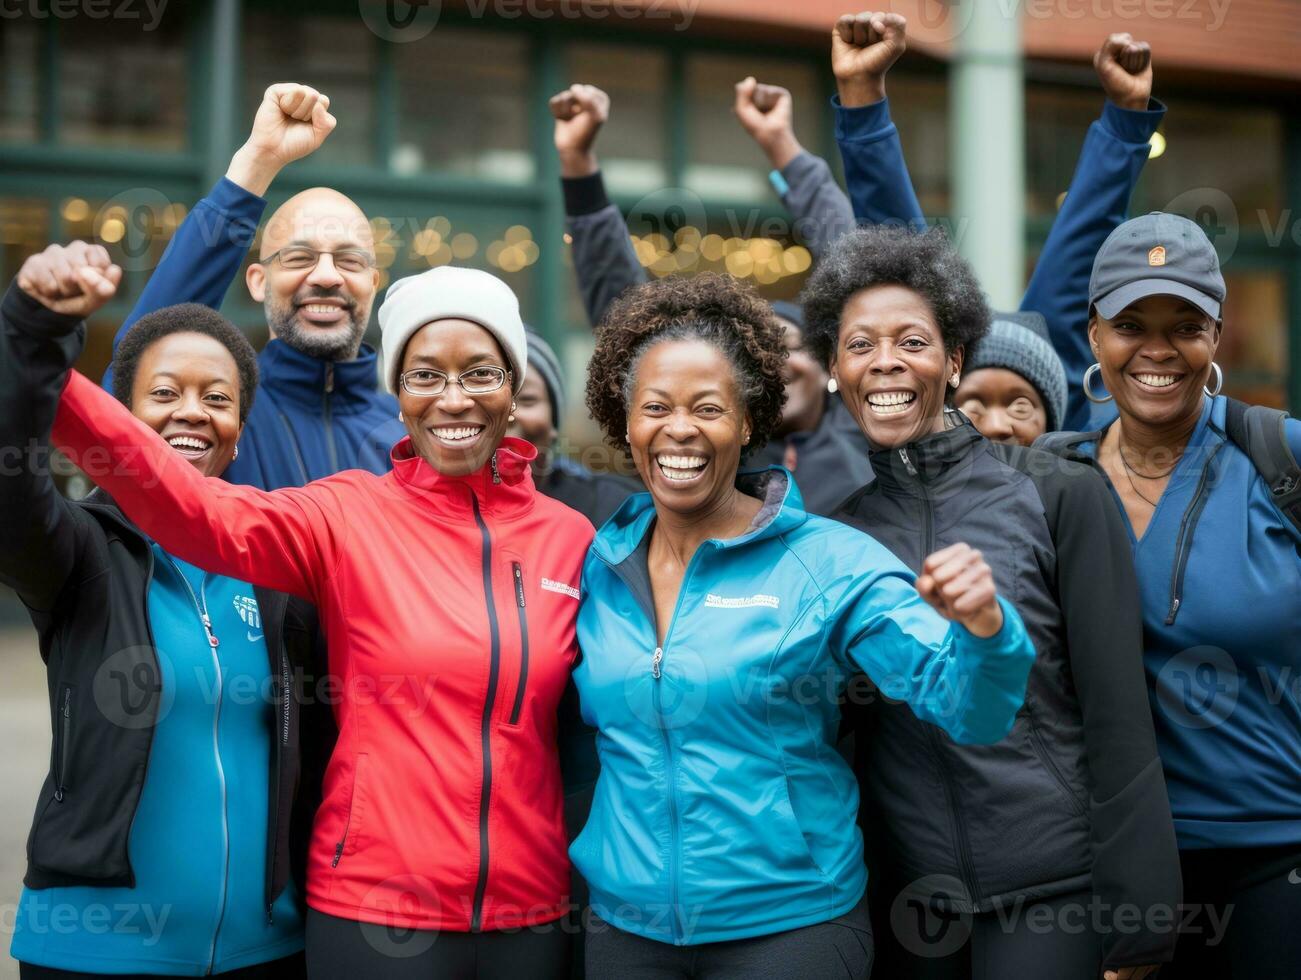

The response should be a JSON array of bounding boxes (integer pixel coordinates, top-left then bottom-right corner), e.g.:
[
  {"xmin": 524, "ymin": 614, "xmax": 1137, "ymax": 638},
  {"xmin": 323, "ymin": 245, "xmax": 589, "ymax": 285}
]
[{"xmin": 52, "ymin": 371, "xmax": 349, "ymax": 605}]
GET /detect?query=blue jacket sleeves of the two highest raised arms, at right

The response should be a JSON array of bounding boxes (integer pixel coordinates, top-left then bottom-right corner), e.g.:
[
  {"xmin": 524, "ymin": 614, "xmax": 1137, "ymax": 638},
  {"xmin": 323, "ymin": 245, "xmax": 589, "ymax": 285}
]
[{"xmin": 831, "ymin": 98, "xmax": 1166, "ymax": 429}]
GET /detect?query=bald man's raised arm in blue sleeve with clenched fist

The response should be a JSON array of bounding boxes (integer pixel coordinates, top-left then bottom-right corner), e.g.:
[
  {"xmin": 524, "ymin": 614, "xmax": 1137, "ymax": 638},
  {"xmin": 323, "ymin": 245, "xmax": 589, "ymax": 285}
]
[{"xmin": 104, "ymin": 82, "xmax": 334, "ymax": 390}]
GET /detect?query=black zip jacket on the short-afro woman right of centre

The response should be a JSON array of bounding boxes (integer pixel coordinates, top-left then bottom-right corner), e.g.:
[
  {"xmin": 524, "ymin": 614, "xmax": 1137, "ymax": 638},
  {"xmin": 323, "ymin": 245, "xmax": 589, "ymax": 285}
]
[{"xmin": 837, "ymin": 413, "xmax": 1181, "ymax": 967}]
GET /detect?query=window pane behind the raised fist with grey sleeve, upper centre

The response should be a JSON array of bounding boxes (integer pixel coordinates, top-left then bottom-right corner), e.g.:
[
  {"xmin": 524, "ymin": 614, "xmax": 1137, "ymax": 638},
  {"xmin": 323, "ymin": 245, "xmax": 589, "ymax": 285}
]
[{"xmin": 684, "ymin": 55, "xmax": 822, "ymax": 200}]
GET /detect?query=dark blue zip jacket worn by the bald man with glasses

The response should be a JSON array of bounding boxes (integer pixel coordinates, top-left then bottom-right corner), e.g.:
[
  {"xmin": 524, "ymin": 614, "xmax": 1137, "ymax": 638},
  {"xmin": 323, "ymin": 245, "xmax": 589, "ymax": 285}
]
[{"xmin": 104, "ymin": 177, "xmax": 398, "ymax": 491}]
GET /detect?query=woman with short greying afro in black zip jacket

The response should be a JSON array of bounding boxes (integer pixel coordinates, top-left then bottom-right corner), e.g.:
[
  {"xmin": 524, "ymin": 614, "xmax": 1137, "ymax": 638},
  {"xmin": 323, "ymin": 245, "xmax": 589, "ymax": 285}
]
[{"xmin": 804, "ymin": 228, "xmax": 1180, "ymax": 980}]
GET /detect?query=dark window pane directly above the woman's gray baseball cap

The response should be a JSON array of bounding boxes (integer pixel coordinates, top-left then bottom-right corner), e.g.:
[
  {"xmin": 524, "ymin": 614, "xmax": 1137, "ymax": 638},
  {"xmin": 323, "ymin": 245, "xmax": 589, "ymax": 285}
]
[{"xmin": 1144, "ymin": 99, "xmax": 1284, "ymax": 218}]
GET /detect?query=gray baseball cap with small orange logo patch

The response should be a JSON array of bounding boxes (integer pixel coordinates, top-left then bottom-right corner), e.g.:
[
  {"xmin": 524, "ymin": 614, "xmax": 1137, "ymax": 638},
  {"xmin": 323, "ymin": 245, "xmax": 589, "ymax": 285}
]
[{"xmin": 1089, "ymin": 211, "xmax": 1224, "ymax": 320}]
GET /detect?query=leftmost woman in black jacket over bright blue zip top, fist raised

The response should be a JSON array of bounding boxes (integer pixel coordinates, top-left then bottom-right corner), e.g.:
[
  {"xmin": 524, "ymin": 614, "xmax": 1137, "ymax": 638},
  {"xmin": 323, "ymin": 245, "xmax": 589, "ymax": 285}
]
[{"xmin": 0, "ymin": 242, "xmax": 329, "ymax": 979}]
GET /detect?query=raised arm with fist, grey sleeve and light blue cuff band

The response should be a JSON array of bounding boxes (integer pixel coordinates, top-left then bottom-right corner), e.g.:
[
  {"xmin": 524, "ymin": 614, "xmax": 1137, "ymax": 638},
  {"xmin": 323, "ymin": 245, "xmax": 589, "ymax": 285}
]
[{"xmin": 732, "ymin": 77, "xmax": 855, "ymax": 258}]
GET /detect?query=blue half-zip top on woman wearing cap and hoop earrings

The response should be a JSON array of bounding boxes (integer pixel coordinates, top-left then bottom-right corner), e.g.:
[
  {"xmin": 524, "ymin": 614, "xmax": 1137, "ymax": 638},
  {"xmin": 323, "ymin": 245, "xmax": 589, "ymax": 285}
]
[{"xmin": 1046, "ymin": 396, "xmax": 1301, "ymax": 849}]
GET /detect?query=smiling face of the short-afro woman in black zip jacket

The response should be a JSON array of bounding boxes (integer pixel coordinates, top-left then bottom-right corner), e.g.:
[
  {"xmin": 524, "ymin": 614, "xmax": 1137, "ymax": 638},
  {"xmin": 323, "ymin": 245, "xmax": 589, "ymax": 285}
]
[{"xmin": 831, "ymin": 285, "xmax": 963, "ymax": 449}]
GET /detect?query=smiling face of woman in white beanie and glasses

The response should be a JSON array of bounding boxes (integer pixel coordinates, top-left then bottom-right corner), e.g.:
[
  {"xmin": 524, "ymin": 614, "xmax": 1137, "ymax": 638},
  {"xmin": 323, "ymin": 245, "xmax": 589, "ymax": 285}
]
[{"xmin": 398, "ymin": 320, "xmax": 511, "ymax": 476}]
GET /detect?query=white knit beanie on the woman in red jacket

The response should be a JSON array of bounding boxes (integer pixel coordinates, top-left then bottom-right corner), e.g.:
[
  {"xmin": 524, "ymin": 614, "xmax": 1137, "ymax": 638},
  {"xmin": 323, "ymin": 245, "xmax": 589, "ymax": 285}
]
[{"xmin": 380, "ymin": 265, "xmax": 528, "ymax": 394}]
